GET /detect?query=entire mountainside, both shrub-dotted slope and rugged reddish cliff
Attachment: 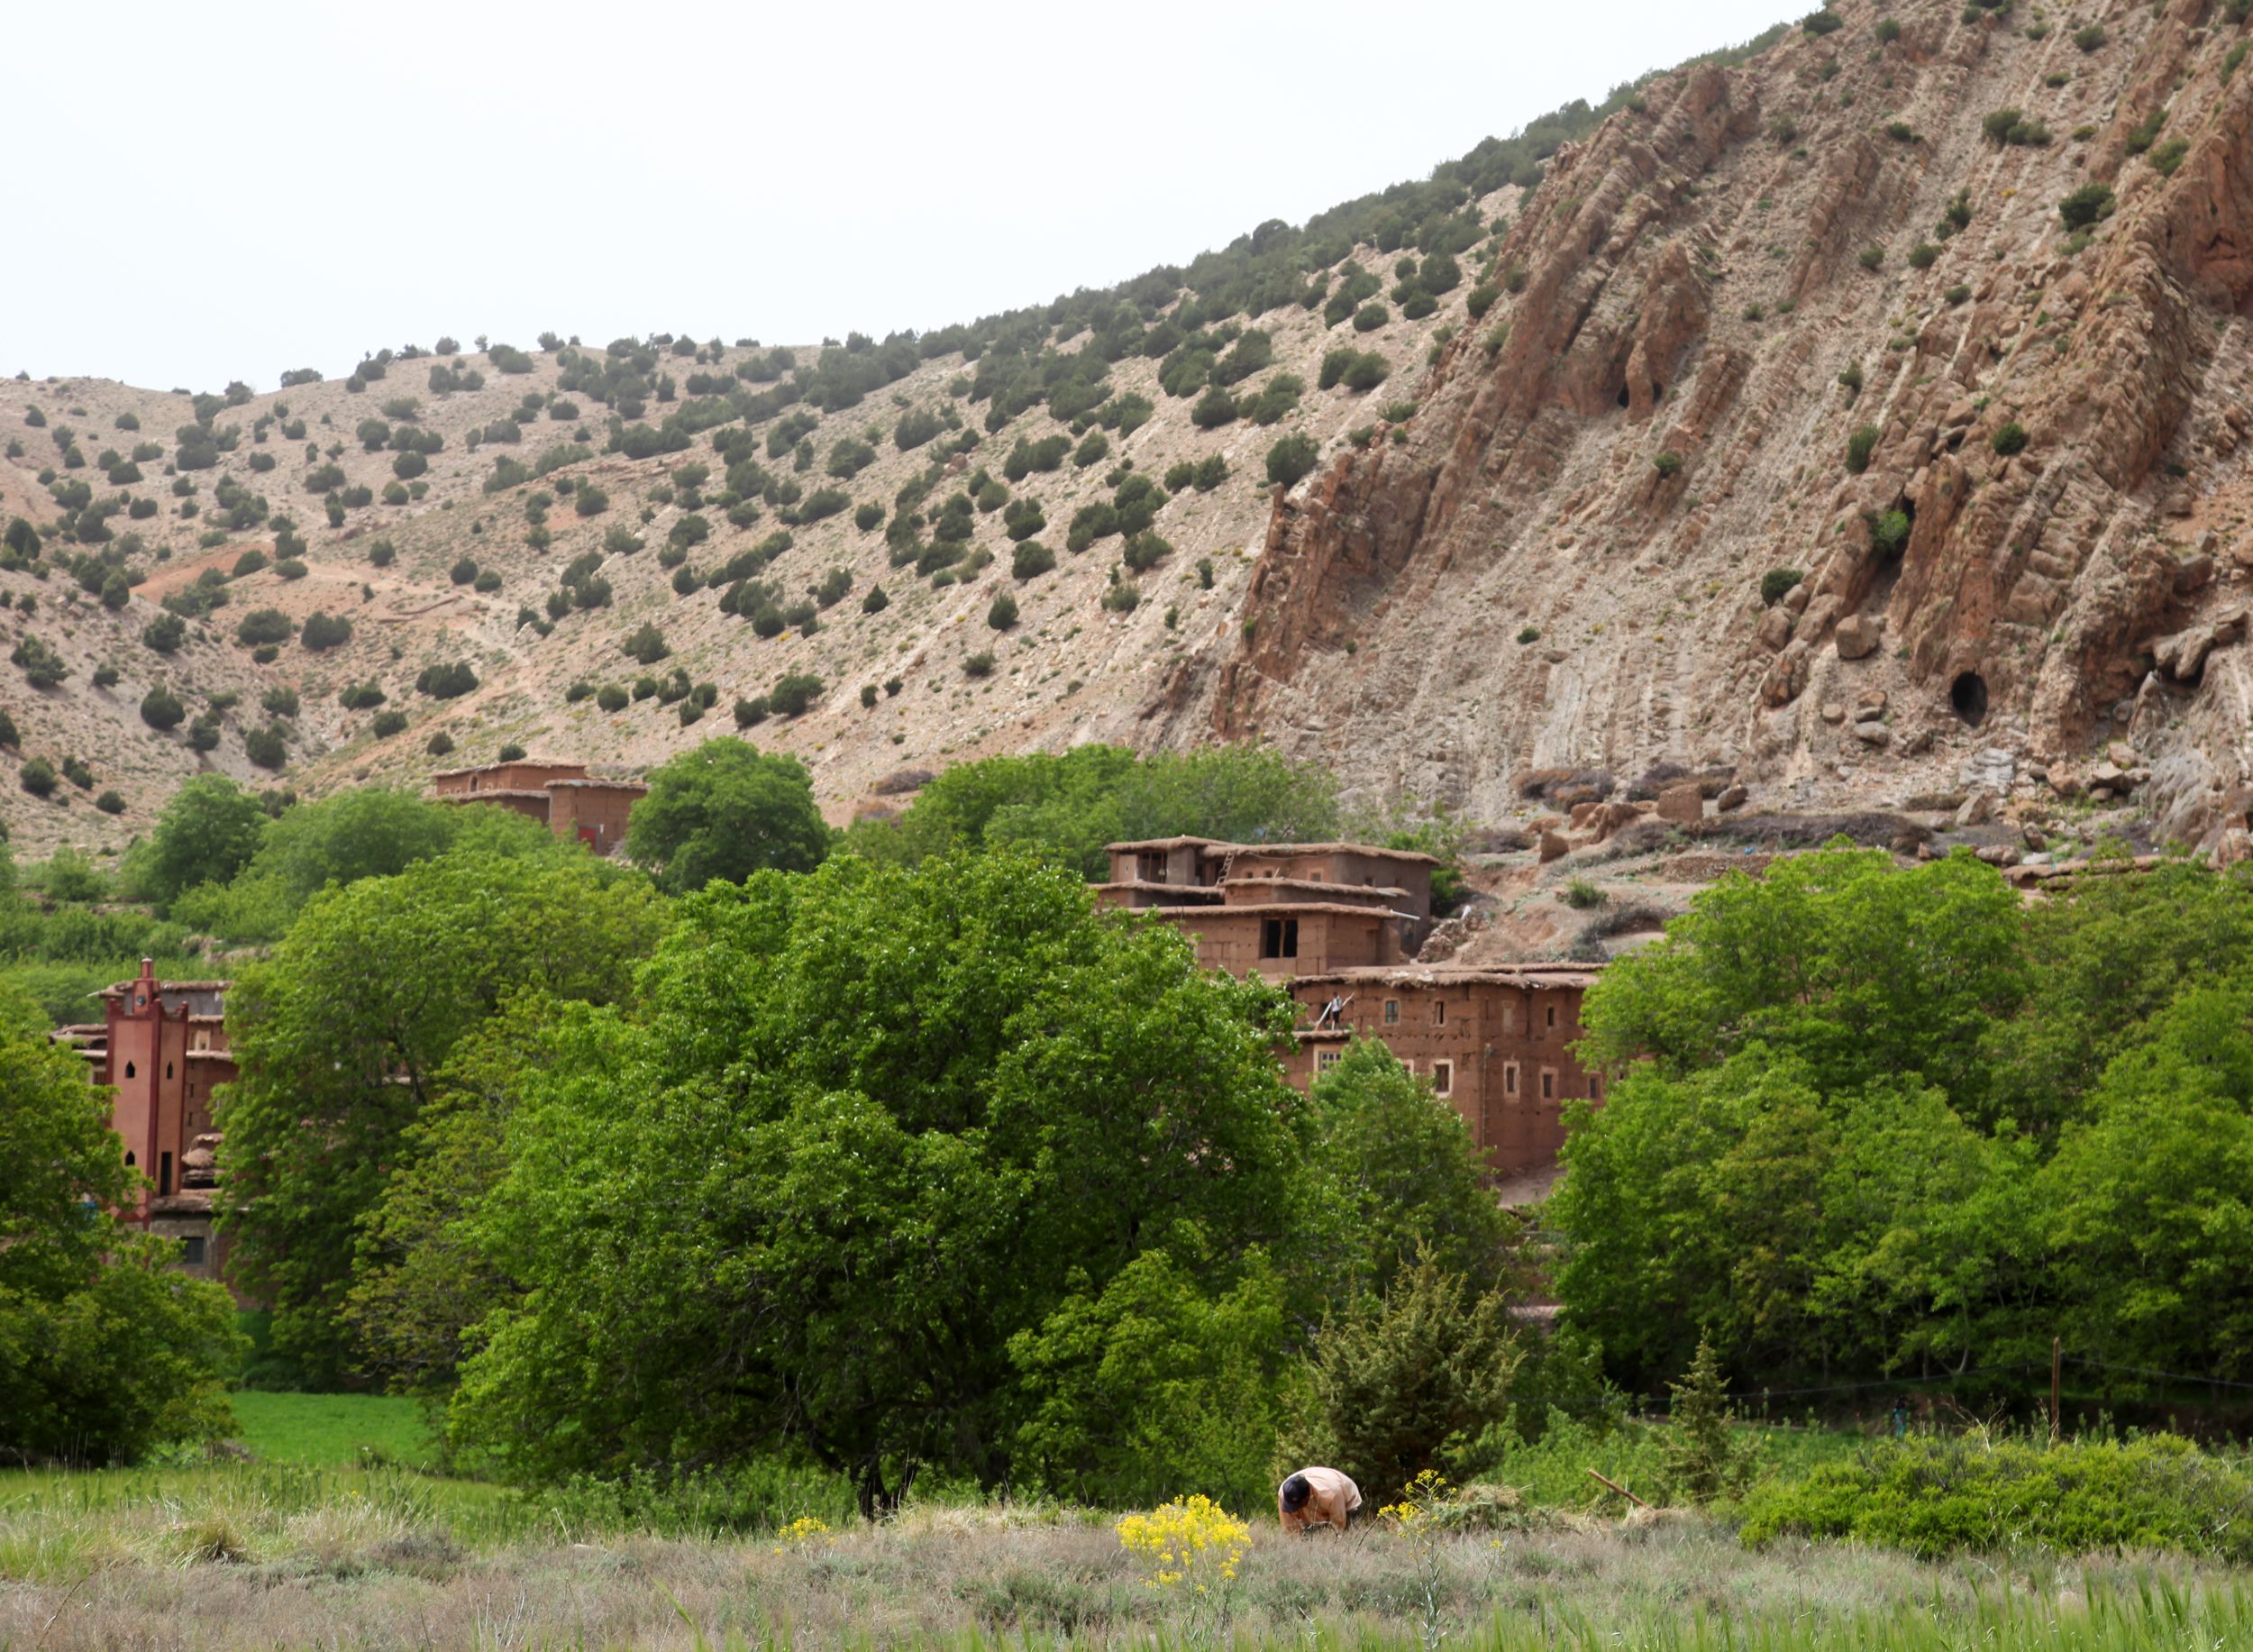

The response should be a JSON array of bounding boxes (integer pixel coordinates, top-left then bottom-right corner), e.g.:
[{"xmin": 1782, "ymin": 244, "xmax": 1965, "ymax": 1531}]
[{"xmin": 0, "ymin": 0, "xmax": 2253, "ymax": 852}]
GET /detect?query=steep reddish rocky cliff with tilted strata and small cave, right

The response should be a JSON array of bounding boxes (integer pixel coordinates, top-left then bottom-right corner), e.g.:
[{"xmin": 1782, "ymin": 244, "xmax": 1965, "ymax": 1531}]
[{"xmin": 1165, "ymin": 0, "xmax": 2253, "ymax": 852}]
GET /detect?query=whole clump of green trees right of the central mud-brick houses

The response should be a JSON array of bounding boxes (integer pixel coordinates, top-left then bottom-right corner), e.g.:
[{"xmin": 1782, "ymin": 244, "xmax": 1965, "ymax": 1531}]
[{"xmin": 1550, "ymin": 850, "xmax": 2253, "ymax": 1382}]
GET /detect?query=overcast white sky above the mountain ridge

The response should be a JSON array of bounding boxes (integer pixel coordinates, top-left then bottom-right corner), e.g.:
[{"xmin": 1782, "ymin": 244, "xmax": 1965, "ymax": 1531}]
[{"xmin": 0, "ymin": 0, "xmax": 1807, "ymax": 390}]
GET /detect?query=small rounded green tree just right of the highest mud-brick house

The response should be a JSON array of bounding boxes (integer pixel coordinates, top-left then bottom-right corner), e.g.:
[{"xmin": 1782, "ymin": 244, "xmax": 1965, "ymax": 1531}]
[{"xmin": 626, "ymin": 737, "xmax": 832, "ymax": 895}]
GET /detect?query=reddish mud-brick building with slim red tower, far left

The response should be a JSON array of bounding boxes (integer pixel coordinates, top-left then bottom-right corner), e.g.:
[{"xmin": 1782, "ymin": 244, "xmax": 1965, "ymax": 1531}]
[{"xmin": 57, "ymin": 958, "xmax": 234, "ymax": 1280}]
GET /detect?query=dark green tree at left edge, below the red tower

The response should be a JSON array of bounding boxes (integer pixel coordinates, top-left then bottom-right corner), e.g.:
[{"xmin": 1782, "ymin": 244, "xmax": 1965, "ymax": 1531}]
[{"xmin": 0, "ymin": 990, "xmax": 242, "ymax": 1465}]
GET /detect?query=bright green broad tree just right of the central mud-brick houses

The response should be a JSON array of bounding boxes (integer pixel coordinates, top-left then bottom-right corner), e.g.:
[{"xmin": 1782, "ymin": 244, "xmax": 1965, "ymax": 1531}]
[{"xmin": 1550, "ymin": 850, "xmax": 2041, "ymax": 1382}]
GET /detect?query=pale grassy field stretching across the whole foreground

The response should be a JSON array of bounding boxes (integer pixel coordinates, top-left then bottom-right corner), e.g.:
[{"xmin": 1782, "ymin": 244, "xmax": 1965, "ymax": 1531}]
[{"xmin": 0, "ymin": 1395, "xmax": 2253, "ymax": 1652}]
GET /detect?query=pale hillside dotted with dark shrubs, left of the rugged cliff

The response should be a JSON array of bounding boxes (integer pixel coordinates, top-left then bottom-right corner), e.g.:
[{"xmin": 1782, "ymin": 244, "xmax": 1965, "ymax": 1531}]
[{"xmin": 0, "ymin": 201, "xmax": 1519, "ymax": 854}]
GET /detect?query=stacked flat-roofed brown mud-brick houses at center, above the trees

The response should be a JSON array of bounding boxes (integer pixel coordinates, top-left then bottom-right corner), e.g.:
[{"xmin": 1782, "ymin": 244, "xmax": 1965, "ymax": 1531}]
[{"xmin": 1095, "ymin": 838, "xmax": 1604, "ymax": 1176}]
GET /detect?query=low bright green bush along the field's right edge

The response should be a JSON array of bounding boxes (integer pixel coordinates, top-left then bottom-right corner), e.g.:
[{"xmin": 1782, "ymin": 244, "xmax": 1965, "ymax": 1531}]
[{"xmin": 1744, "ymin": 1433, "xmax": 2253, "ymax": 1564}]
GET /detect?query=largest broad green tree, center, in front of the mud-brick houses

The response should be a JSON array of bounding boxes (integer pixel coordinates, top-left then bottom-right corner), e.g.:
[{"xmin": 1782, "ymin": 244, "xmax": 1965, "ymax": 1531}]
[{"xmin": 453, "ymin": 854, "xmax": 1296, "ymax": 1512}]
